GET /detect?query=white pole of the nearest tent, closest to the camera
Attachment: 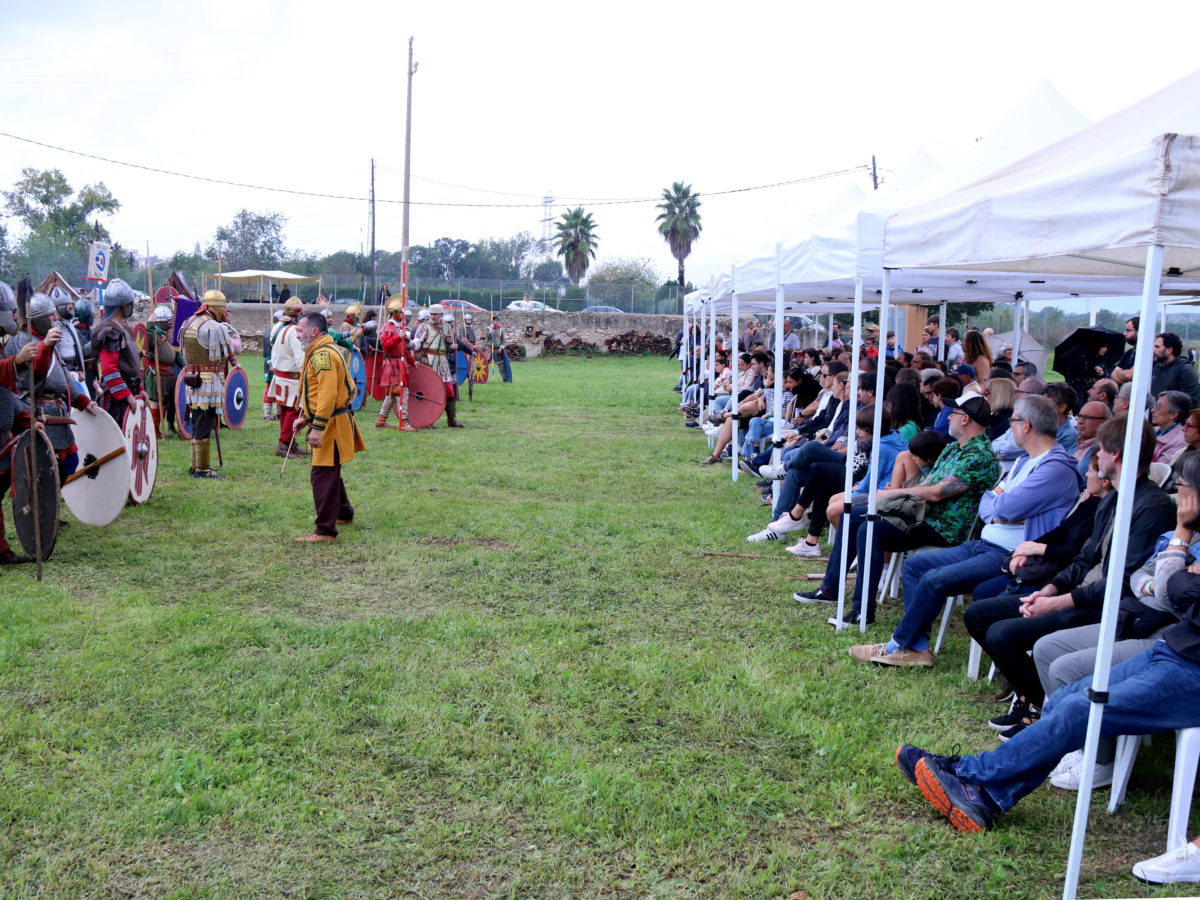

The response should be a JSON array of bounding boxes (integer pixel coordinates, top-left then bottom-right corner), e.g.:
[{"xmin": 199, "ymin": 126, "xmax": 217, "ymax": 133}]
[{"xmin": 1062, "ymin": 244, "xmax": 1163, "ymax": 900}]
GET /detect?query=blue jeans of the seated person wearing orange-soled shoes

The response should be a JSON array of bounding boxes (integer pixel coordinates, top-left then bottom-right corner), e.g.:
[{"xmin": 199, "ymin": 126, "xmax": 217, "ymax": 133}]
[{"xmin": 955, "ymin": 641, "xmax": 1200, "ymax": 812}]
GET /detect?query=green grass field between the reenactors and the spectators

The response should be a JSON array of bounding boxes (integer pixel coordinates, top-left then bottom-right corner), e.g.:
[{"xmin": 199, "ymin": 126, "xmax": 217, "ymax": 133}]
[{"xmin": 0, "ymin": 358, "xmax": 1196, "ymax": 898}]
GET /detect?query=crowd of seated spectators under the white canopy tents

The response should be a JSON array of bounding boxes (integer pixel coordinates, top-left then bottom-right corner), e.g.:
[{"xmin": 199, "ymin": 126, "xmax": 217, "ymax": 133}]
[{"xmin": 678, "ymin": 318, "xmax": 1200, "ymax": 882}]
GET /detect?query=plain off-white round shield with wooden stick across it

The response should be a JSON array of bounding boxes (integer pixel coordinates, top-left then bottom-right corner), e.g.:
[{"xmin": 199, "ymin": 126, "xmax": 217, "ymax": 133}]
[{"xmin": 62, "ymin": 409, "xmax": 128, "ymax": 527}]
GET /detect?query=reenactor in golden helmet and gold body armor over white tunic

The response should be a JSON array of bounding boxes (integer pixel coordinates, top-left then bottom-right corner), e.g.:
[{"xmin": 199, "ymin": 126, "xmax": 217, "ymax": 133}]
[{"xmin": 179, "ymin": 290, "xmax": 240, "ymax": 478}]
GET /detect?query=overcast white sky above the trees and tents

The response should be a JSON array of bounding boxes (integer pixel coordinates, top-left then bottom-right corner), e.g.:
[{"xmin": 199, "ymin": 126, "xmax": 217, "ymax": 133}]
[{"xmin": 0, "ymin": 0, "xmax": 1200, "ymax": 303}]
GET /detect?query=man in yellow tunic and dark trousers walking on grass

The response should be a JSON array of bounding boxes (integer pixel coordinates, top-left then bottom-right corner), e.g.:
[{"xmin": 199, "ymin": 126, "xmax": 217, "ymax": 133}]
[{"xmin": 295, "ymin": 312, "xmax": 367, "ymax": 544}]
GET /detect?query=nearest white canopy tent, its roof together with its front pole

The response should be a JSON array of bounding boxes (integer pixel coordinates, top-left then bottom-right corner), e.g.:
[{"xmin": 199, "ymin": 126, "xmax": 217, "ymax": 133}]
[{"xmin": 883, "ymin": 72, "xmax": 1200, "ymax": 900}]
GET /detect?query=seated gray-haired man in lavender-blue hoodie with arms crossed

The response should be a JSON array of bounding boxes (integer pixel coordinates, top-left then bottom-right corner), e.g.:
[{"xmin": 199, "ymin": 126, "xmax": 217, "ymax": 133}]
[{"xmin": 850, "ymin": 397, "xmax": 1079, "ymax": 666}]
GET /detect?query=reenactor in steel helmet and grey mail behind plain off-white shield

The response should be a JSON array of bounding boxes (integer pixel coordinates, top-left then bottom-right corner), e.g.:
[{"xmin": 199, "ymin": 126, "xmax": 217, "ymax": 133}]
[{"xmin": 5, "ymin": 294, "xmax": 97, "ymax": 478}]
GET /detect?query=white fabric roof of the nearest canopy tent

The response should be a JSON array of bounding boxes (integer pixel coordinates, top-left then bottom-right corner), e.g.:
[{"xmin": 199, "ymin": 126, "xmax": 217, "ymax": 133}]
[{"xmin": 884, "ymin": 72, "xmax": 1200, "ymax": 285}]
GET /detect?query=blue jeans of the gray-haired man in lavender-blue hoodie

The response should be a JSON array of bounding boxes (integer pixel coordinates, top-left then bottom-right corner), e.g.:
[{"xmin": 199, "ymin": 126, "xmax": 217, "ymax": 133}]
[{"xmin": 892, "ymin": 541, "xmax": 1007, "ymax": 650}]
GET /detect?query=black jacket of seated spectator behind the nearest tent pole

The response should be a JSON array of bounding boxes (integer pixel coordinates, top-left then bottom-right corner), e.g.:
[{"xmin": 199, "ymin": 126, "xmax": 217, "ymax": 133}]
[{"xmin": 1050, "ymin": 476, "xmax": 1175, "ymax": 610}]
